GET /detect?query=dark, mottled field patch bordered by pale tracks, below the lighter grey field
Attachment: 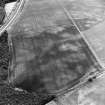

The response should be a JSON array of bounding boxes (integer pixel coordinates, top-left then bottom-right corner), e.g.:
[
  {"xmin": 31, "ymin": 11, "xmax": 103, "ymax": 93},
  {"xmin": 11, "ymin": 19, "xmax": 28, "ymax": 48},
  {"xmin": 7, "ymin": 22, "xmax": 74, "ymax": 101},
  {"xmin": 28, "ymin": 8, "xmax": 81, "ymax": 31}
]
[{"xmin": 10, "ymin": 23, "xmax": 99, "ymax": 92}]
